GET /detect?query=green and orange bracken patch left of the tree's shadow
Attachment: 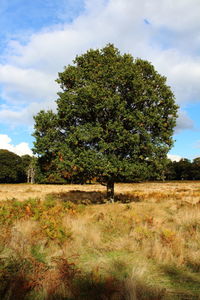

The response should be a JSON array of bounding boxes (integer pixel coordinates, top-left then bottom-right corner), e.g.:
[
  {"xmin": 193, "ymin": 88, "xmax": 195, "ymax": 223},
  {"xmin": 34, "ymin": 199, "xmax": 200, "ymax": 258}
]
[{"xmin": 0, "ymin": 197, "xmax": 72, "ymax": 243}]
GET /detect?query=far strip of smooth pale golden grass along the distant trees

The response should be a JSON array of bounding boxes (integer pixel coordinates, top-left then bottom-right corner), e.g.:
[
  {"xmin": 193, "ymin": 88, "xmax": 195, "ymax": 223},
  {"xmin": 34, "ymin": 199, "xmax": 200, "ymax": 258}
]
[{"xmin": 0, "ymin": 181, "xmax": 200, "ymax": 205}]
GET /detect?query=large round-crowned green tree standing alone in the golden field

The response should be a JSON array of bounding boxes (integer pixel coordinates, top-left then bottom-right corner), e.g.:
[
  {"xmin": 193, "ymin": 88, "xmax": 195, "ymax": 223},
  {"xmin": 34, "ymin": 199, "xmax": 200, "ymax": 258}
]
[{"xmin": 33, "ymin": 45, "xmax": 177, "ymax": 199}]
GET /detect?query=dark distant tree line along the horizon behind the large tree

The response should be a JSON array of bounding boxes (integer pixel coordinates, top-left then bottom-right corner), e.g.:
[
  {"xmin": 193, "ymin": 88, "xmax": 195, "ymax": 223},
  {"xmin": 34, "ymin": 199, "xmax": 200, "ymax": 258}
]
[{"xmin": 0, "ymin": 149, "xmax": 200, "ymax": 184}]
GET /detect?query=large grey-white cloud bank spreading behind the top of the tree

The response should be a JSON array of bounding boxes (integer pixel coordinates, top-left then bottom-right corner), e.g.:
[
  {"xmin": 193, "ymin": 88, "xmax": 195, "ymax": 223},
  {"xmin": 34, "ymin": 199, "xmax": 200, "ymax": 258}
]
[{"xmin": 0, "ymin": 0, "xmax": 200, "ymax": 130}]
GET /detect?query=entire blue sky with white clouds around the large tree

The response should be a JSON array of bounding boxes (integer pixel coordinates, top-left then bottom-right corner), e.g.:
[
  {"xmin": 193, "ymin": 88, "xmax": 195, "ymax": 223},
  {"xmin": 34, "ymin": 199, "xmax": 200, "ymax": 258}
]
[{"xmin": 0, "ymin": 0, "xmax": 200, "ymax": 160}]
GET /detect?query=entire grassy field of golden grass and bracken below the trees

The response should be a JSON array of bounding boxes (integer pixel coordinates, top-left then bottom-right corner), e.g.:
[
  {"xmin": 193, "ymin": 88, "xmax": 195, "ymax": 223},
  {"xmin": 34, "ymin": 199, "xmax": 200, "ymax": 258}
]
[{"xmin": 0, "ymin": 182, "xmax": 200, "ymax": 300}]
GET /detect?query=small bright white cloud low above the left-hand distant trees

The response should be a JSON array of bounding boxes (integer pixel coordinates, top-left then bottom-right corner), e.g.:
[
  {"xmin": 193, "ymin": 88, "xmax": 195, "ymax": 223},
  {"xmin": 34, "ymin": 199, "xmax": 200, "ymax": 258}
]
[{"xmin": 0, "ymin": 134, "xmax": 33, "ymax": 156}]
